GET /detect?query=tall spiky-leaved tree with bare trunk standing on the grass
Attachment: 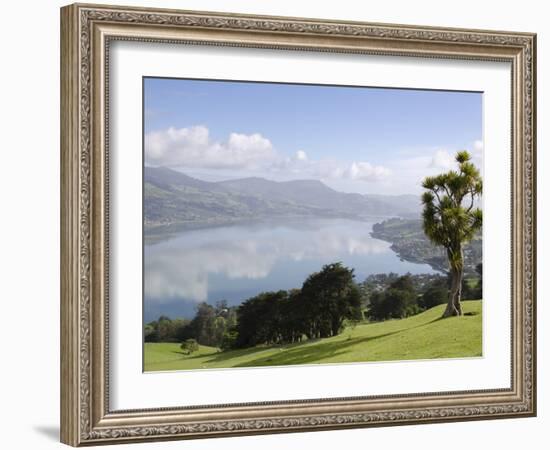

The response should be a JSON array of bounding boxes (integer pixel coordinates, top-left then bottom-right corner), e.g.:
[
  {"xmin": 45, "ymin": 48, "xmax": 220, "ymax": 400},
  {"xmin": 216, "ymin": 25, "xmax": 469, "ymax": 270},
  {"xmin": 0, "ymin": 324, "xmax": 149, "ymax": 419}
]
[{"xmin": 422, "ymin": 151, "xmax": 483, "ymax": 317}]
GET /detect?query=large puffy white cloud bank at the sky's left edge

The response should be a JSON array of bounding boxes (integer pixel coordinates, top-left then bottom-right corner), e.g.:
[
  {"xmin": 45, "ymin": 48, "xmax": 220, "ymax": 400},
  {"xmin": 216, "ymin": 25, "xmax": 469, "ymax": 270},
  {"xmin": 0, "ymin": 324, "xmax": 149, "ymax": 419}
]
[{"xmin": 145, "ymin": 126, "xmax": 277, "ymax": 169}]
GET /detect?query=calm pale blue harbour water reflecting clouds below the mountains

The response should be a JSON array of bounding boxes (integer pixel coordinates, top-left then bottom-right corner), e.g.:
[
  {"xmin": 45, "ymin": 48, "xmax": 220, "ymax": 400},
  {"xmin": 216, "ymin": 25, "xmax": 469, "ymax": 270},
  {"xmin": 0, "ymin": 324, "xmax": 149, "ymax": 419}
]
[{"xmin": 143, "ymin": 219, "xmax": 435, "ymax": 322}]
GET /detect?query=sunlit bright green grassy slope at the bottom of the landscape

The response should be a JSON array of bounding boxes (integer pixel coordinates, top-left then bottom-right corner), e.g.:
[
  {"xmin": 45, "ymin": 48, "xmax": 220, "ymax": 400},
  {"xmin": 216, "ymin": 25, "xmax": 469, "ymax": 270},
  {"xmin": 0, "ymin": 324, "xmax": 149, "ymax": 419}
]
[{"xmin": 144, "ymin": 300, "xmax": 482, "ymax": 372}]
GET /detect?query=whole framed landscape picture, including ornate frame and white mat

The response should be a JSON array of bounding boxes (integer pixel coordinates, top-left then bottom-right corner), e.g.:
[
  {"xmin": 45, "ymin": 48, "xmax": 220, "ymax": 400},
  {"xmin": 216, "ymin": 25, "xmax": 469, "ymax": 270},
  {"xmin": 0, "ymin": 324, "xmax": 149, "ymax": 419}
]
[{"xmin": 61, "ymin": 4, "xmax": 536, "ymax": 446}]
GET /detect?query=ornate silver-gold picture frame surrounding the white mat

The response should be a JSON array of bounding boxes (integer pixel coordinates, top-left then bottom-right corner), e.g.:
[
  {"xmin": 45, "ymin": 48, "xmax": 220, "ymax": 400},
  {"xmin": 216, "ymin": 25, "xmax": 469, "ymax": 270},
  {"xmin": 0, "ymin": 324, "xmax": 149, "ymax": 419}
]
[{"xmin": 61, "ymin": 4, "xmax": 536, "ymax": 446}]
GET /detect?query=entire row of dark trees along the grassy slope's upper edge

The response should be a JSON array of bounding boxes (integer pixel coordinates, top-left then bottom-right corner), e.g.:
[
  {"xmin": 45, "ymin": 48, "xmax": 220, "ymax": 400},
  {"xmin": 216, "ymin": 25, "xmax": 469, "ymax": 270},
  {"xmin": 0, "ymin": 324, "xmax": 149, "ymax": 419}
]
[{"xmin": 145, "ymin": 263, "xmax": 482, "ymax": 352}]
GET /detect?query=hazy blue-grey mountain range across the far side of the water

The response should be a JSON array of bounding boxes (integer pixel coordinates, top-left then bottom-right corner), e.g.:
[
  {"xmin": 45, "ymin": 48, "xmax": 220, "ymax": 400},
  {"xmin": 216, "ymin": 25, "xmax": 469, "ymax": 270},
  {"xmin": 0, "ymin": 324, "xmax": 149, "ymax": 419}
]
[{"xmin": 144, "ymin": 167, "xmax": 420, "ymax": 230}]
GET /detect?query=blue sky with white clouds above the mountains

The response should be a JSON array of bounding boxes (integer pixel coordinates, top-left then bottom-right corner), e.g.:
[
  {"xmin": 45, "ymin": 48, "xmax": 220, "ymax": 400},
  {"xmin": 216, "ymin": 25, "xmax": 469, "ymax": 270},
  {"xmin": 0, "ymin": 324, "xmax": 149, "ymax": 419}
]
[{"xmin": 144, "ymin": 78, "xmax": 483, "ymax": 194}]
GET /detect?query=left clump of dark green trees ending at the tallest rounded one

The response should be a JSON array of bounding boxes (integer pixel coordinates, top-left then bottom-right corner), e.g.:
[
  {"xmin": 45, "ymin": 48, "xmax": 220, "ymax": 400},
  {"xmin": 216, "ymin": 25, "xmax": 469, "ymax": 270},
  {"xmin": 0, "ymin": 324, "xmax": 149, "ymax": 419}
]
[{"xmin": 145, "ymin": 263, "xmax": 364, "ymax": 352}]
